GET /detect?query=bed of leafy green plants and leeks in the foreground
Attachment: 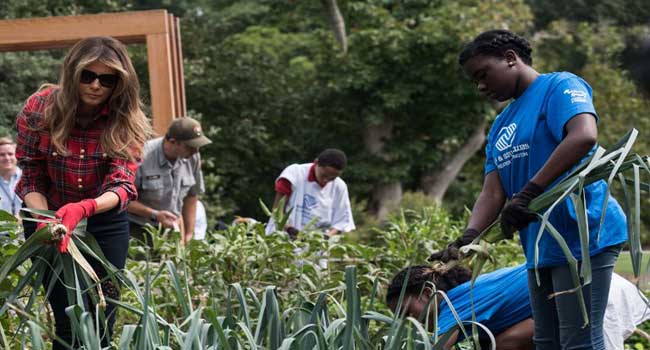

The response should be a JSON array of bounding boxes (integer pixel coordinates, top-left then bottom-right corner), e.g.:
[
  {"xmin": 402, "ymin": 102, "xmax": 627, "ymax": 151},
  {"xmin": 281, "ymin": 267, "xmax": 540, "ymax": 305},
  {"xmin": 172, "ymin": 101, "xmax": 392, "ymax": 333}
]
[{"xmin": 0, "ymin": 205, "xmax": 521, "ymax": 349}]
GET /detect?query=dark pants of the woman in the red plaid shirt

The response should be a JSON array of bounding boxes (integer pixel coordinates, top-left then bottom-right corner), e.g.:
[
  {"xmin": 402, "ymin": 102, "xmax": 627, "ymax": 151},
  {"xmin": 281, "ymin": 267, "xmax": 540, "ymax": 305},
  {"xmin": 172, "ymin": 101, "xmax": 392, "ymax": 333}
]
[{"xmin": 23, "ymin": 208, "xmax": 129, "ymax": 350}]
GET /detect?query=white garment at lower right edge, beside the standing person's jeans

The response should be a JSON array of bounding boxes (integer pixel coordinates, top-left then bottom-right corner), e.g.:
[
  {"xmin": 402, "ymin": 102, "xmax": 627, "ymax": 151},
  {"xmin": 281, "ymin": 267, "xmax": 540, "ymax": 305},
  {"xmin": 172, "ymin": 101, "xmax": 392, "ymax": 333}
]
[{"xmin": 603, "ymin": 273, "xmax": 650, "ymax": 350}]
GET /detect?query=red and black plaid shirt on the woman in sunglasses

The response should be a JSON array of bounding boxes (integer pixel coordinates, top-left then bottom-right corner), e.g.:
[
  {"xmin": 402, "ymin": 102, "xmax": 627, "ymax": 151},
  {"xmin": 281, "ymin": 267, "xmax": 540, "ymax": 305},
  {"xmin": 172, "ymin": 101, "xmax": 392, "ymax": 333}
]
[{"xmin": 16, "ymin": 88, "xmax": 138, "ymax": 210}]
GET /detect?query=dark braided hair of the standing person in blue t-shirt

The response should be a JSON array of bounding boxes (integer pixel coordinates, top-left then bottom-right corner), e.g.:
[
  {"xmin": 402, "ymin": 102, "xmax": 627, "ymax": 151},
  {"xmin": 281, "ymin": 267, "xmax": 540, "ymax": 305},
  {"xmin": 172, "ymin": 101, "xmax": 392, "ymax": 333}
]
[{"xmin": 458, "ymin": 29, "xmax": 533, "ymax": 66}]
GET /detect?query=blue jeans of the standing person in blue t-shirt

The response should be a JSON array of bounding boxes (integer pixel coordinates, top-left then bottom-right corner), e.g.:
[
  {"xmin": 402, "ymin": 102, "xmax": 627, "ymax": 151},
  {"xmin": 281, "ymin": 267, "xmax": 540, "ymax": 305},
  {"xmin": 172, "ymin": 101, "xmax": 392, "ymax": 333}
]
[{"xmin": 528, "ymin": 245, "xmax": 621, "ymax": 350}]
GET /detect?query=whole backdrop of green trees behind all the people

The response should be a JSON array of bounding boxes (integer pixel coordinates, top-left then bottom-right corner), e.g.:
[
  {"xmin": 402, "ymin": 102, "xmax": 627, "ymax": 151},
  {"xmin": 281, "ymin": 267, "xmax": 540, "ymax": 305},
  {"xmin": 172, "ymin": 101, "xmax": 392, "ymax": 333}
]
[{"xmin": 0, "ymin": 0, "xmax": 650, "ymax": 234}]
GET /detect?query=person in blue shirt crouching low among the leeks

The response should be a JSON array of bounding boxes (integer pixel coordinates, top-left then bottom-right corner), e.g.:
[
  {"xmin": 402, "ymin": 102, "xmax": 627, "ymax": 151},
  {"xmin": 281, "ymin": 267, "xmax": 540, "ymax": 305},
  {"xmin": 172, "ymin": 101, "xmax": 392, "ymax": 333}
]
[{"xmin": 386, "ymin": 265, "xmax": 650, "ymax": 350}]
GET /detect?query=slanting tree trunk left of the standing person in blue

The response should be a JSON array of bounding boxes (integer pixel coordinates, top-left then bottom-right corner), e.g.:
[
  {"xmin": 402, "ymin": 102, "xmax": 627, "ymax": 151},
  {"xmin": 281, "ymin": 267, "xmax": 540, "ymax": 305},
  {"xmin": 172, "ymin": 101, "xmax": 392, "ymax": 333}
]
[{"xmin": 420, "ymin": 120, "xmax": 487, "ymax": 202}]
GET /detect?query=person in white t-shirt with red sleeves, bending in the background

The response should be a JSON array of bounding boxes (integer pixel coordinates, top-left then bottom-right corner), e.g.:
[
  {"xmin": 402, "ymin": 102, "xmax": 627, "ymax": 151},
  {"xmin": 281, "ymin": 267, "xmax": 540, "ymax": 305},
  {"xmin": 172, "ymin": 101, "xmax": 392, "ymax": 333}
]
[{"xmin": 266, "ymin": 149, "xmax": 355, "ymax": 238}]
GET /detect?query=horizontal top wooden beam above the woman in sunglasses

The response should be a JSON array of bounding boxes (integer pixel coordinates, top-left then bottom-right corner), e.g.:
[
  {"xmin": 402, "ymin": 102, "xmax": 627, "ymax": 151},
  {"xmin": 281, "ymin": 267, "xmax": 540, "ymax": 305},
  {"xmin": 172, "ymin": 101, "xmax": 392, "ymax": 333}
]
[{"xmin": 0, "ymin": 10, "xmax": 168, "ymax": 51}]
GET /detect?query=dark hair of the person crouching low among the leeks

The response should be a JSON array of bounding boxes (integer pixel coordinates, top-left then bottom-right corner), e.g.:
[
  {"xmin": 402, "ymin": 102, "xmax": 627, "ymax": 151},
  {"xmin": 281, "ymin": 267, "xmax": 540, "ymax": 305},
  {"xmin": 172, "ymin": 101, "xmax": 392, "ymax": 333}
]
[{"xmin": 386, "ymin": 265, "xmax": 472, "ymax": 303}]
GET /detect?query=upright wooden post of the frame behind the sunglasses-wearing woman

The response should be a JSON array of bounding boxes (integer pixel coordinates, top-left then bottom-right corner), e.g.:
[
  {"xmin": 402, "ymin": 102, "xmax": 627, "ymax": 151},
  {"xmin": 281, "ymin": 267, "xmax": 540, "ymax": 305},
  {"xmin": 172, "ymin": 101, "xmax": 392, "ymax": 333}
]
[{"xmin": 147, "ymin": 34, "xmax": 176, "ymax": 135}]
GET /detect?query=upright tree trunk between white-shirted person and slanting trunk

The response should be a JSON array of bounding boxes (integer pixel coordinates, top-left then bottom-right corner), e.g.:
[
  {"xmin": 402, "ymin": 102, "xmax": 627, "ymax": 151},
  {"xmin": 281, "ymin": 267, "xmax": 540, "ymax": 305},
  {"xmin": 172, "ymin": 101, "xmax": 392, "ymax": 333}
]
[{"xmin": 362, "ymin": 118, "xmax": 402, "ymax": 220}]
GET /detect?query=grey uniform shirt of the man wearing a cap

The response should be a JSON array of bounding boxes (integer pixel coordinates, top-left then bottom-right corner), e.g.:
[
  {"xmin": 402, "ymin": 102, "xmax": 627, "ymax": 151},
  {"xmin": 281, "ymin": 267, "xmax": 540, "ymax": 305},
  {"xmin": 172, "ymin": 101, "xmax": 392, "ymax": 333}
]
[{"xmin": 129, "ymin": 137, "xmax": 205, "ymax": 226}]
